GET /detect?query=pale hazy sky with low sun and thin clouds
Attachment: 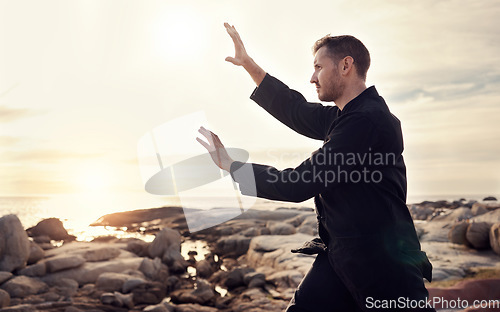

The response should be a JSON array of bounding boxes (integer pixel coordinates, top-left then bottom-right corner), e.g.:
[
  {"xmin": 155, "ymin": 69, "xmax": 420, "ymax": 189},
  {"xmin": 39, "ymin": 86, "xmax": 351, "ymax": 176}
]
[{"xmin": 0, "ymin": 0, "xmax": 500, "ymax": 200}]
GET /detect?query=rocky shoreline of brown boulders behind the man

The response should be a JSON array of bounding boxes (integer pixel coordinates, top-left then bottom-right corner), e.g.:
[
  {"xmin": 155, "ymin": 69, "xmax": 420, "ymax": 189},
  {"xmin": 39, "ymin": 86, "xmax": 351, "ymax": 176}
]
[{"xmin": 0, "ymin": 200, "xmax": 500, "ymax": 312}]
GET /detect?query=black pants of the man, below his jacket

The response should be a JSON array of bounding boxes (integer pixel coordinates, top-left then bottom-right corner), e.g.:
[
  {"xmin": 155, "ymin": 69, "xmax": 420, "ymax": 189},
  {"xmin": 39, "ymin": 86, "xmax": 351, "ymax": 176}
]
[{"xmin": 286, "ymin": 252, "xmax": 435, "ymax": 312}]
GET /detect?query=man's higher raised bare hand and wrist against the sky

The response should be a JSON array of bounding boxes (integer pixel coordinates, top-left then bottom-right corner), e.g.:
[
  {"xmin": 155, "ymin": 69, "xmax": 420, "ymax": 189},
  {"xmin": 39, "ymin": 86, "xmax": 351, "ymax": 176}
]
[{"xmin": 224, "ymin": 23, "xmax": 266, "ymax": 86}]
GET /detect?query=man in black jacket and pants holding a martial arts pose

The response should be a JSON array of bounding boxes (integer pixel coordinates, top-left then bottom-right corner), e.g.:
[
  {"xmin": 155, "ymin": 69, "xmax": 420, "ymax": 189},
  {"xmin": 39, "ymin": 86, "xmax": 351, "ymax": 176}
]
[{"xmin": 198, "ymin": 23, "xmax": 435, "ymax": 312}]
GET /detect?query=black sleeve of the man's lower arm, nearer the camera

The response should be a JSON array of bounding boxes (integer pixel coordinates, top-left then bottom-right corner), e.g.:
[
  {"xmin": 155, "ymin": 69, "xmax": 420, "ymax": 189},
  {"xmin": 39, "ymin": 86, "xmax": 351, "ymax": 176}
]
[{"xmin": 230, "ymin": 114, "xmax": 377, "ymax": 202}]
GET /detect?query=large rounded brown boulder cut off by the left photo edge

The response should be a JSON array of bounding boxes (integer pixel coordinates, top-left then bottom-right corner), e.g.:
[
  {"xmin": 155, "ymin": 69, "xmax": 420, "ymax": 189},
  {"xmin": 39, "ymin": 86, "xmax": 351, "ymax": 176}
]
[{"xmin": 0, "ymin": 215, "xmax": 30, "ymax": 272}]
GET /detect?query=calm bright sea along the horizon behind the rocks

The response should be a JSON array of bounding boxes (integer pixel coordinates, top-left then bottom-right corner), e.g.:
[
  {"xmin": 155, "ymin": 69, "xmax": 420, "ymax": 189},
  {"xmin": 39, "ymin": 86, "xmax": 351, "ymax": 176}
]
[{"xmin": 0, "ymin": 194, "xmax": 494, "ymax": 240}]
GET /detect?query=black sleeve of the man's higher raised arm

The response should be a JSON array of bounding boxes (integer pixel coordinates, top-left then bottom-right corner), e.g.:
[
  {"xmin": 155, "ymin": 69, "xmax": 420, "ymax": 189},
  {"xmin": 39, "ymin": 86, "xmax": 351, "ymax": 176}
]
[{"xmin": 250, "ymin": 74, "xmax": 338, "ymax": 140}]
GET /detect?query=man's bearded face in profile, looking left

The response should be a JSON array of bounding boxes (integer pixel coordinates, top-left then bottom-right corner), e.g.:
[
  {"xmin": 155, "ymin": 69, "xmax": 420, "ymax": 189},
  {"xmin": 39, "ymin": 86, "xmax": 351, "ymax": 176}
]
[{"xmin": 311, "ymin": 47, "xmax": 345, "ymax": 102}]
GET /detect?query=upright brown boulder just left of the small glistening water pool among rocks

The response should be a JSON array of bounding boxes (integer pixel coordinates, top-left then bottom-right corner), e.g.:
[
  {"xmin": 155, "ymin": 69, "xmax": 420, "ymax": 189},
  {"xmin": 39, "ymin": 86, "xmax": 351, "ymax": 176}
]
[{"xmin": 148, "ymin": 228, "xmax": 187, "ymax": 273}]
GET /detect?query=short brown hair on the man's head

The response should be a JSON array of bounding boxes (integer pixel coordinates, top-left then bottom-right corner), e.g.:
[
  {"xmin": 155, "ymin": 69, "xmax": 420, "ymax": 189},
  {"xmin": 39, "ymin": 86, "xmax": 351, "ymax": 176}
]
[{"xmin": 313, "ymin": 35, "xmax": 370, "ymax": 80}]
